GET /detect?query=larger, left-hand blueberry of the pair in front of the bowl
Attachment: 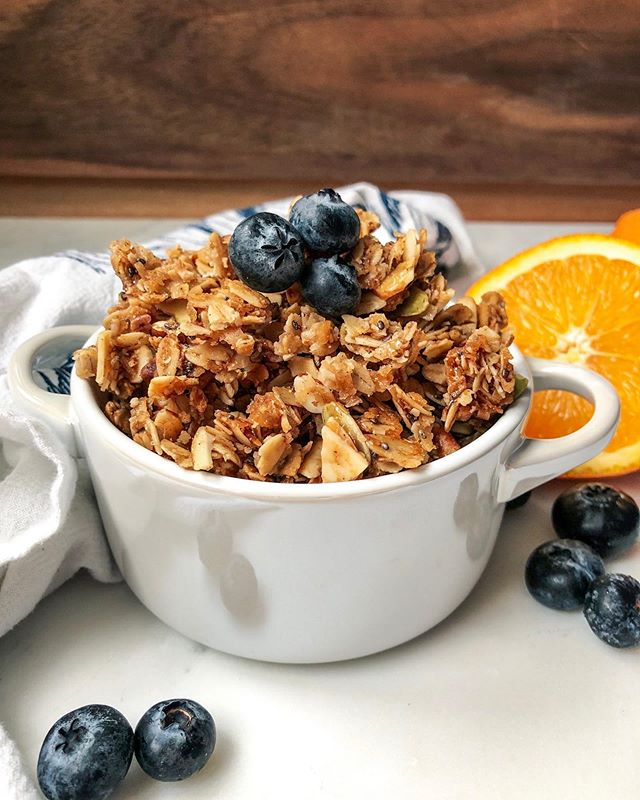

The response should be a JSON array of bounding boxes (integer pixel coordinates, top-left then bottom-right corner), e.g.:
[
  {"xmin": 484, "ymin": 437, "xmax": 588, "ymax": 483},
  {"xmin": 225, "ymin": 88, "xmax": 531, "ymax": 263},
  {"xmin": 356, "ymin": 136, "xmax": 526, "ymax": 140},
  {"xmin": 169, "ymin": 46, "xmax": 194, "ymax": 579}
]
[{"xmin": 38, "ymin": 705, "xmax": 133, "ymax": 800}]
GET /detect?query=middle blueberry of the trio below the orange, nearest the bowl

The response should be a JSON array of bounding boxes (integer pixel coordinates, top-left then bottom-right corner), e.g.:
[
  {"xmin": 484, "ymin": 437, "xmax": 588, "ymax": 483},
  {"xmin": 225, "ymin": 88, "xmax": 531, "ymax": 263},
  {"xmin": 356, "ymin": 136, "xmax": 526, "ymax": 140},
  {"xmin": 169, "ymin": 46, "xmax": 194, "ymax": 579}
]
[{"xmin": 524, "ymin": 539, "xmax": 604, "ymax": 611}]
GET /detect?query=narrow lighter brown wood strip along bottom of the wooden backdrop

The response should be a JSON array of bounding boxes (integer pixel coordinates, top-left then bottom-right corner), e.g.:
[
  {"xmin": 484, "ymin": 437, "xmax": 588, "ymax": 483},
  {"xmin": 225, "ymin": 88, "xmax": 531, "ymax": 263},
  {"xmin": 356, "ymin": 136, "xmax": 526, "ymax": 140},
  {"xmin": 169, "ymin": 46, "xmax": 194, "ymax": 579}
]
[{"xmin": 0, "ymin": 177, "xmax": 640, "ymax": 222}]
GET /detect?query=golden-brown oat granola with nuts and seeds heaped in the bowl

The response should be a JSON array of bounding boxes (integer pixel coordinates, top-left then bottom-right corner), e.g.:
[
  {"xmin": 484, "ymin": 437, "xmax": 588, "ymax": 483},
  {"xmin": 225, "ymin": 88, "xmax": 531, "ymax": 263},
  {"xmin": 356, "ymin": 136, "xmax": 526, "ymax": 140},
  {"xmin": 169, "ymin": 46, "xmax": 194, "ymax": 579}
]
[{"xmin": 75, "ymin": 211, "xmax": 515, "ymax": 483}]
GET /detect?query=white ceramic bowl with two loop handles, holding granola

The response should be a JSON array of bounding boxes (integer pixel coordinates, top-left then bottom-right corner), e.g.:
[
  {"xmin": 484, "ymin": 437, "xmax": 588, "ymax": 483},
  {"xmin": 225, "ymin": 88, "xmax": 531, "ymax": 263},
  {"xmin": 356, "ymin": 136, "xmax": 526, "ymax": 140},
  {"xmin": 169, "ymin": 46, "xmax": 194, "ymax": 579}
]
[{"xmin": 9, "ymin": 326, "xmax": 619, "ymax": 663}]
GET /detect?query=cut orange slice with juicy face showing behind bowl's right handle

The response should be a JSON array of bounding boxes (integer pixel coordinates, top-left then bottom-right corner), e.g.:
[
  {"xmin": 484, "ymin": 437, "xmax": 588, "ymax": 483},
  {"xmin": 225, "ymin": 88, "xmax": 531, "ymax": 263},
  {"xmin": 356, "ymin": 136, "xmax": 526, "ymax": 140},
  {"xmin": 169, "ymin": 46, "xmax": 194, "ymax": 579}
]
[{"xmin": 469, "ymin": 234, "xmax": 640, "ymax": 478}]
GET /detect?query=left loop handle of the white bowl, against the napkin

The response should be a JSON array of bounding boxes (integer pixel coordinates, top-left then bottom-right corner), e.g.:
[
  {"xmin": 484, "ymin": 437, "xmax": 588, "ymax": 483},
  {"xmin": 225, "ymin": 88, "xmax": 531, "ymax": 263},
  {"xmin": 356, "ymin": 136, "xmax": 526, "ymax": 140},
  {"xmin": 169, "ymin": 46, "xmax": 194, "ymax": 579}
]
[{"xmin": 7, "ymin": 325, "xmax": 96, "ymax": 455}]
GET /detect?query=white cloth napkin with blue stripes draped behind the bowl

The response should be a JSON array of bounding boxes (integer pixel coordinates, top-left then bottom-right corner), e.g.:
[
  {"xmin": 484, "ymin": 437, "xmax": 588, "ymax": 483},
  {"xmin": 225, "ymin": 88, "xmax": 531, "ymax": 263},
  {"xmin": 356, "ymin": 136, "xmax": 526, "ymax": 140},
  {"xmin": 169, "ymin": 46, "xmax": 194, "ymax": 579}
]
[{"xmin": 0, "ymin": 183, "xmax": 482, "ymax": 800}]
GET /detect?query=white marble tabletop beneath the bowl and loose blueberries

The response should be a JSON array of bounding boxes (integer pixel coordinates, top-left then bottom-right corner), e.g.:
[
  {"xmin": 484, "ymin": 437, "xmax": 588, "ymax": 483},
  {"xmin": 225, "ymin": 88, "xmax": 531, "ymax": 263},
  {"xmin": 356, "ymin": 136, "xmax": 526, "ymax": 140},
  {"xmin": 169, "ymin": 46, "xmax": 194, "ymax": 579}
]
[{"xmin": 0, "ymin": 220, "xmax": 640, "ymax": 800}]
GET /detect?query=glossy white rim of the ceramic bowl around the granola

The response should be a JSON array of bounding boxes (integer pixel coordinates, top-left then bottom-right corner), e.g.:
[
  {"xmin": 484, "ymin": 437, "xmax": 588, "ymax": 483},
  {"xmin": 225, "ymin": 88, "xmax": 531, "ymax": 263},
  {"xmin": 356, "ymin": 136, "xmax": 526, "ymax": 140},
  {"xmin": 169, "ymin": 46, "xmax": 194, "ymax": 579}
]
[{"xmin": 70, "ymin": 328, "xmax": 534, "ymax": 503}]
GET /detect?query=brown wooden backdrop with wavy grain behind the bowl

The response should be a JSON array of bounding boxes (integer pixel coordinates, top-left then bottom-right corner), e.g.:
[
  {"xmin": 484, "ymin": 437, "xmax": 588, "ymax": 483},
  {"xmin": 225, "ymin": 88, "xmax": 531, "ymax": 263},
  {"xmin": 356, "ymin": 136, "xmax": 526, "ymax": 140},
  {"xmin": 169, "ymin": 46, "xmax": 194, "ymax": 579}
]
[{"xmin": 0, "ymin": 0, "xmax": 640, "ymax": 219}]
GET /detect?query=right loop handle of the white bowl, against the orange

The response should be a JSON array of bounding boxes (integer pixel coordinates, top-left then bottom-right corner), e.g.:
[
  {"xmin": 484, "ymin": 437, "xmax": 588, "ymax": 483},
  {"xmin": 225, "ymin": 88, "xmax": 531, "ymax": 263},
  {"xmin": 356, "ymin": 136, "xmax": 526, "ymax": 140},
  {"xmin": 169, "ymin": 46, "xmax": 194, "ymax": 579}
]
[{"xmin": 497, "ymin": 358, "xmax": 620, "ymax": 503}]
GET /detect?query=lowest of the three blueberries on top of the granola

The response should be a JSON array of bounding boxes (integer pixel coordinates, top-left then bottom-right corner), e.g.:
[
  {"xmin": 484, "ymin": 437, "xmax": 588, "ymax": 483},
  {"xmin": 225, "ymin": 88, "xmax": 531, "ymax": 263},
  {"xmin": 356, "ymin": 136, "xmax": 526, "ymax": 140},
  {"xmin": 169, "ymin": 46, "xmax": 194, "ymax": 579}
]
[{"xmin": 300, "ymin": 256, "xmax": 361, "ymax": 317}]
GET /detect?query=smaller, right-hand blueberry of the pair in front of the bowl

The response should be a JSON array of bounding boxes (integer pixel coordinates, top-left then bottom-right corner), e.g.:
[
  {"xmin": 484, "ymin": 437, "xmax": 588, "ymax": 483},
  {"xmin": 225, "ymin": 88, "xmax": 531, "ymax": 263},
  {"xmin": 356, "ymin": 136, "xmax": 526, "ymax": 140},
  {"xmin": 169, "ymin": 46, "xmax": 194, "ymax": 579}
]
[{"xmin": 135, "ymin": 700, "xmax": 216, "ymax": 781}]
